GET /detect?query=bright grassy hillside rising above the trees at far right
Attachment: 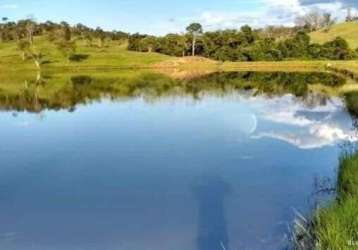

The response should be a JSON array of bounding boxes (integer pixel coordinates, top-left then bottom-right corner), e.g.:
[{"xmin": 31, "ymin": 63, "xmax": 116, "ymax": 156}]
[{"xmin": 311, "ymin": 21, "xmax": 358, "ymax": 49}]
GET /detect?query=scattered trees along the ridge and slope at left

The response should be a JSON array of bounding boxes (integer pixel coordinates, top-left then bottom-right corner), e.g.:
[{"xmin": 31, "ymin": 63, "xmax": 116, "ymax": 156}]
[{"xmin": 0, "ymin": 17, "xmax": 129, "ymax": 69}]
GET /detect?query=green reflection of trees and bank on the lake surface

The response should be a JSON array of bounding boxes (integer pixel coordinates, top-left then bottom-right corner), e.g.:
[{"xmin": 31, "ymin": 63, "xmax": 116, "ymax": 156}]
[{"xmin": 0, "ymin": 70, "xmax": 343, "ymax": 112}]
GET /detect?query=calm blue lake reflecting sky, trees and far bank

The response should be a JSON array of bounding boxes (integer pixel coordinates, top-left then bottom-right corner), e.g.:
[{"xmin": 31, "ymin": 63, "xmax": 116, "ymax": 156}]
[{"xmin": 0, "ymin": 71, "xmax": 357, "ymax": 250}]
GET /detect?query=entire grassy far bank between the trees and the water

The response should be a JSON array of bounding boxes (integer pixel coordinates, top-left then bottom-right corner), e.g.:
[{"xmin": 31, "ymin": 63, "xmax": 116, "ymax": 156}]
[{"xmin": 0, "ymin": 37, "xmax": 358, "ymax": 79}]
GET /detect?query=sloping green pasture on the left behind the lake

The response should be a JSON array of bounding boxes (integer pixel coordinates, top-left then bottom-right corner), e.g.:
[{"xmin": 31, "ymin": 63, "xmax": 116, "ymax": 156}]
[{"xmin": 0, "ymin": 37, "xmax": 170, "ymax": 71}]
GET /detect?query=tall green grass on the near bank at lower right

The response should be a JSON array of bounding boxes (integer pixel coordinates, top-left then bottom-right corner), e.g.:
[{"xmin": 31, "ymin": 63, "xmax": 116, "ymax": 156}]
[{"xmin": 315, "ymin": 153, "xmax": 358, "ymax": 250}]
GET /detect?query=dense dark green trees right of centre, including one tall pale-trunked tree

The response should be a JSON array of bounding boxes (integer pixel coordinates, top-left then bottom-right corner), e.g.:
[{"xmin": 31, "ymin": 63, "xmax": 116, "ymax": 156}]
[{"xmin": 128, "ymin": 23, "xmax": 358, "ymax": 61}]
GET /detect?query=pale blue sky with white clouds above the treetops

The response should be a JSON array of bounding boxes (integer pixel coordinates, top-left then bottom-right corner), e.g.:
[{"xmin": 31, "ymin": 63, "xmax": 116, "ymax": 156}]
[{"xmin": 0, "ymin": 0, "xmax": 358, "ymax": 34}]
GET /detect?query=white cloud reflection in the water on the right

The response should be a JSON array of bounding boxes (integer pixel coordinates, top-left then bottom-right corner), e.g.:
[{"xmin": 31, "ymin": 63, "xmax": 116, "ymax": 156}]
[{"xmin": 245, "ymin": 95, "xmax": 358, "ymax": 149}]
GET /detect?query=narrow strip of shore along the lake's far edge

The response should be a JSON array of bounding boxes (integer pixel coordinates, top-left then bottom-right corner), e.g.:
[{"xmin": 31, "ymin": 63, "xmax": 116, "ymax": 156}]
[{"xmin": 0, "ymin": 57, "xmax": 358, "ymax": 75}]
